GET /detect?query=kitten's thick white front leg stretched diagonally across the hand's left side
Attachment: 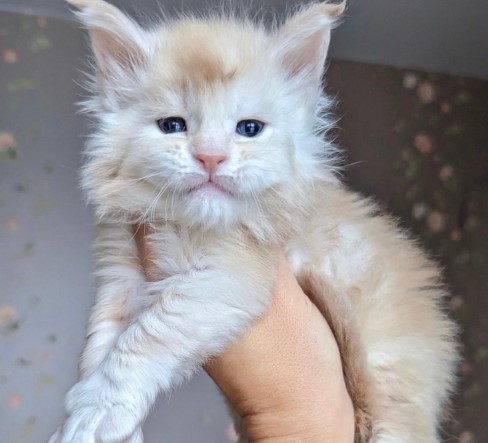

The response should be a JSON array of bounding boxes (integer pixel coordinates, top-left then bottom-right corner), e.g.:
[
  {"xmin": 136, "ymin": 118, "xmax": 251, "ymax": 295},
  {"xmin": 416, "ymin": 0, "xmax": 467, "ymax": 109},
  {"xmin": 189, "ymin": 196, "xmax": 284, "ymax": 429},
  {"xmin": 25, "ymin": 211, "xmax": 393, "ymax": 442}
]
[{"xmin": 54, "ymin": 258, "xmax": 275, "ymax": 443}]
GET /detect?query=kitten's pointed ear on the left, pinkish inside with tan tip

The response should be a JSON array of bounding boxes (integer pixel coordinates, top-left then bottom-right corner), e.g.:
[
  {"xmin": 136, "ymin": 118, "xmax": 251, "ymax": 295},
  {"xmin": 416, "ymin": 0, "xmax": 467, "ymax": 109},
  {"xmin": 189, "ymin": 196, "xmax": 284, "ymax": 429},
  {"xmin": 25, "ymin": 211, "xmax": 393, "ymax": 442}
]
[{"xmin": 66, "ymin": 0, "xmax": 147, "ymax": 78}]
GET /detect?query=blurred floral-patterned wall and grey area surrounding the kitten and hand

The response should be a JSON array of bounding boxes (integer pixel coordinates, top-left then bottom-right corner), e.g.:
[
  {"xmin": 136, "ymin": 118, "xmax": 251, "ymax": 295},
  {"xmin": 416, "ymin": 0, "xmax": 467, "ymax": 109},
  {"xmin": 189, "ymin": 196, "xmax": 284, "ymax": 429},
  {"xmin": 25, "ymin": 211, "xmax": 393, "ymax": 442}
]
[{"xmin": 0, "ymin": 0, "xmax": 488, "ymax": 443}]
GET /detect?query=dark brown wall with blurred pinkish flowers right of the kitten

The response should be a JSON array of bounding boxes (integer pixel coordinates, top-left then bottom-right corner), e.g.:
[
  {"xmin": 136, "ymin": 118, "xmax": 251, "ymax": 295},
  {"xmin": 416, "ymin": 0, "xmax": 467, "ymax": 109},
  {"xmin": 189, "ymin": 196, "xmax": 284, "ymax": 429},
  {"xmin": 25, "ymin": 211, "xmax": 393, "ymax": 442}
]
[{"xmin": 328, "ymin": 61, "xmax": 488, "ymax": 443}]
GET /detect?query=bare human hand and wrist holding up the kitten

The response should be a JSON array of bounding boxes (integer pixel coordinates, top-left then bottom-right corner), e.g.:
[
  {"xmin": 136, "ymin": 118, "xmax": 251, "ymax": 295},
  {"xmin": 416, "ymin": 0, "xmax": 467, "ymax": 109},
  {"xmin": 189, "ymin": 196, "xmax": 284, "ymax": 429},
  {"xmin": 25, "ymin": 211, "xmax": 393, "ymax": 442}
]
[{"xmin": 136, "ymin": 229, "xmax": 354, "ymax": 443}]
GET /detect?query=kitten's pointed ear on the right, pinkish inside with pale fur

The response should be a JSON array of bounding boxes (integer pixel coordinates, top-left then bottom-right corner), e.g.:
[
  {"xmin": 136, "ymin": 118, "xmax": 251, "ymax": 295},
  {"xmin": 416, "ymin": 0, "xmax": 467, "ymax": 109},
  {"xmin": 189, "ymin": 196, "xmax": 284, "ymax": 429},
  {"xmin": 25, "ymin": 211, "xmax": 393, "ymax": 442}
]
[{"xmin": 277, "ymin": 1, "xmax": 345, "ymax": 86}]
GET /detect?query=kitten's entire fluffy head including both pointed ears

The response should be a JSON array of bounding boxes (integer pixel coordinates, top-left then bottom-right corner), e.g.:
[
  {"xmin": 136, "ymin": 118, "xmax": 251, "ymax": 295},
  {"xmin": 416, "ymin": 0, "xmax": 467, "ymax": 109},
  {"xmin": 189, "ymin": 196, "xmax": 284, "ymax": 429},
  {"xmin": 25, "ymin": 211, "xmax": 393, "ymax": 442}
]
[{"xmin": 74, "ymin": 0, "xmax": 343, "ymax": 239}]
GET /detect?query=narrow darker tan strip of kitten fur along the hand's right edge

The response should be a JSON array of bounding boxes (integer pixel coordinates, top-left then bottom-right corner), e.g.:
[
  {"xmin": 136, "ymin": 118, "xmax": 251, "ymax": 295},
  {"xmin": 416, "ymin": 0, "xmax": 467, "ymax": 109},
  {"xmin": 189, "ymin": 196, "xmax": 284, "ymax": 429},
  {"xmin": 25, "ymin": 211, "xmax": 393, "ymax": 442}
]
[{"xmin": 297, "ymin": 266, "xmax": 375, "ymax": 443}]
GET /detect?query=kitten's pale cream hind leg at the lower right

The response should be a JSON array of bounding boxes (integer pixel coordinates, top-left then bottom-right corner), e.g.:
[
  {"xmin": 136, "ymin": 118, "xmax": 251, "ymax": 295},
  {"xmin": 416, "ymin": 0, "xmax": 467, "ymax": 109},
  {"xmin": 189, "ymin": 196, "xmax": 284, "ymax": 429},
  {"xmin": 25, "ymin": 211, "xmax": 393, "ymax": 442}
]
[{"xmin": 362, "ymin": 290, "xmax": 457, "ymax": 443}]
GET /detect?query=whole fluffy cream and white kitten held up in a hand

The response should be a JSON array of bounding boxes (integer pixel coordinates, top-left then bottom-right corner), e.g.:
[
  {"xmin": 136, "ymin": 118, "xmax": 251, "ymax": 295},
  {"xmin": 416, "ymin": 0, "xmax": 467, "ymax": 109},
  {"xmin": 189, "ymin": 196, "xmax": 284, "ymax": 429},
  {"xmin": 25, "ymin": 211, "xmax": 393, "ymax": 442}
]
[{"xmin": 50, "ymin": 0, "xmax": 456, "ymax": 443}]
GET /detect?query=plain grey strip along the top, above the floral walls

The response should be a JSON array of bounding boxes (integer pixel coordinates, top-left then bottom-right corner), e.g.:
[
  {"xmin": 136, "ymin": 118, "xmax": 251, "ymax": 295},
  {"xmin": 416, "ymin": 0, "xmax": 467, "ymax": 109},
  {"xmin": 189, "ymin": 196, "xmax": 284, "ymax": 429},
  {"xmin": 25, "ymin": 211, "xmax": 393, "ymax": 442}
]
[{"xmin": 0, "ymin": 0, "xmax": 488, "ymax": 78}]
